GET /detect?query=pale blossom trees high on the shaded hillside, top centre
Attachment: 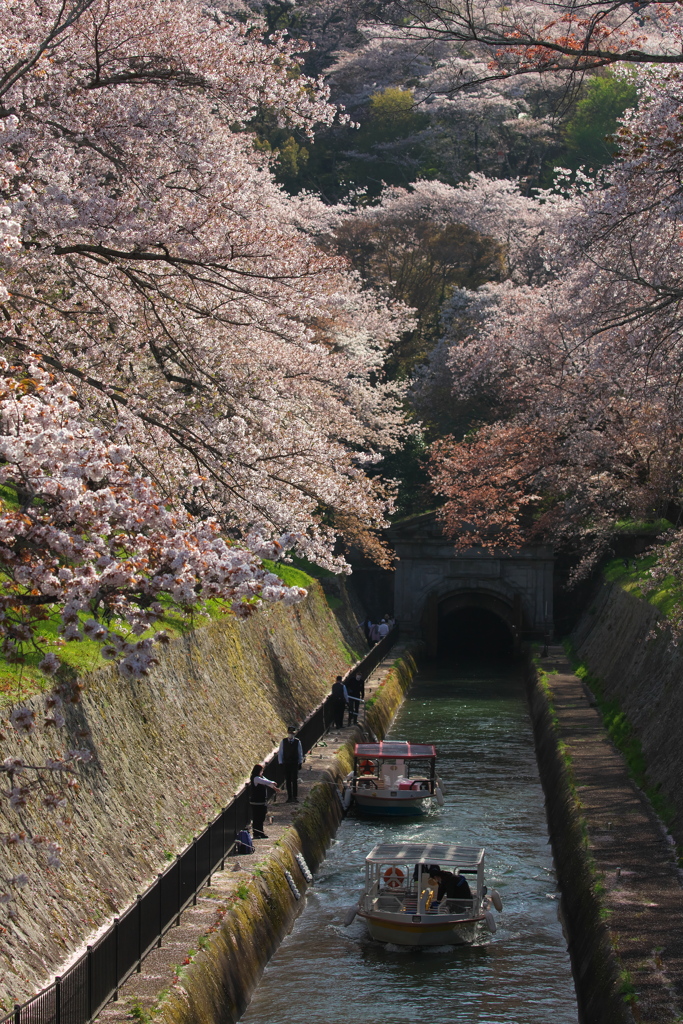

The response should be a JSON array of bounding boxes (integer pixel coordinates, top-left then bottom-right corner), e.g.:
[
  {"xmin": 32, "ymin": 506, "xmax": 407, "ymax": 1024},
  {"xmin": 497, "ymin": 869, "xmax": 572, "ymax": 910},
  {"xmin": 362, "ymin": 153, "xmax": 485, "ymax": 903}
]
[{"xmin": 327, "ymin": 22, "xmax": 565, "ymax": 182}]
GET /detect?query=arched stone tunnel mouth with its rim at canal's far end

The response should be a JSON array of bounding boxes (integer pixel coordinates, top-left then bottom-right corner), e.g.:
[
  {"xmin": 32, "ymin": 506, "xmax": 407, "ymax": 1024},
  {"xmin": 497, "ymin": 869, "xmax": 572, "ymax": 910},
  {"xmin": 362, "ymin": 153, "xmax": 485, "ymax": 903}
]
[{"xmin": 422, "ymin": 589, "xmax": 524, "ymax": 657}]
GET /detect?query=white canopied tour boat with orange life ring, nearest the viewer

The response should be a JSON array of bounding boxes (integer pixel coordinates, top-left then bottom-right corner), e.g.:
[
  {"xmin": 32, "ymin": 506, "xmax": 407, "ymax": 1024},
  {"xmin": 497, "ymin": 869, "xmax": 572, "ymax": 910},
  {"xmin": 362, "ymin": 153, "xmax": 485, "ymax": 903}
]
[{"xmin": 345, "ymin": 843, "xmax": 503, "ymax": 946}]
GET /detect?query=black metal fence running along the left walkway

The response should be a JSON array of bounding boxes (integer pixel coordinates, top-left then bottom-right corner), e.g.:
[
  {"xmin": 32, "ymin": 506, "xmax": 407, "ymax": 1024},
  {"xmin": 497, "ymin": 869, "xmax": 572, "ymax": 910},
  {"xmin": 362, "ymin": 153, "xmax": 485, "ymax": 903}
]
[{"xmin": 0, "ymin": 629, "xmax": 396, "ymax": 1024}]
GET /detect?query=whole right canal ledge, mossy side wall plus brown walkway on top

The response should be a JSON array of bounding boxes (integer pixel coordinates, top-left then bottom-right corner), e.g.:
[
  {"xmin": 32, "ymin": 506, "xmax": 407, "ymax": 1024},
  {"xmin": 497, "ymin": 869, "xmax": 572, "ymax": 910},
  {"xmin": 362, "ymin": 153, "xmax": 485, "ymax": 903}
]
[{"xmin": 526, "ymin": 647, "xmax": 683, "ymax": 1024}]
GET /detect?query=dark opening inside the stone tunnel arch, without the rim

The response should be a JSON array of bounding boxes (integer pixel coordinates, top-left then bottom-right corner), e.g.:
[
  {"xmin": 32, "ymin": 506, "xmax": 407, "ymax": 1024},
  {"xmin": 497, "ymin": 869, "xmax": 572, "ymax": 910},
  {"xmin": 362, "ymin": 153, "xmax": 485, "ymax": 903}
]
[{"xmin": 437, "ymin": 604, "xmax": 515, "ymax": 659}]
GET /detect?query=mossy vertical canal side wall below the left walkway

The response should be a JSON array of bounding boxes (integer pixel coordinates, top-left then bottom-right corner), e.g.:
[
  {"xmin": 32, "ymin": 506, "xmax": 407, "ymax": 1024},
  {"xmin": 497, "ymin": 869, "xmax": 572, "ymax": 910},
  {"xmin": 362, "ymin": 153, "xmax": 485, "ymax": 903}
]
[{"xmin": 143, "ymin": 644, "xmax": 417, "ymax": 1024}]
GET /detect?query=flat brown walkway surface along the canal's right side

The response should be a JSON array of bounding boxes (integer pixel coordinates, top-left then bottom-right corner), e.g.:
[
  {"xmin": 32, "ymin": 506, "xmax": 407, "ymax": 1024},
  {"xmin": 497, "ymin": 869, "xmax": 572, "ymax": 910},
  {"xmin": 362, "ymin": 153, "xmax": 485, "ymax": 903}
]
[{"xmin": 541, "ymin": 647, "xmax": 683, "ymax": 1024}]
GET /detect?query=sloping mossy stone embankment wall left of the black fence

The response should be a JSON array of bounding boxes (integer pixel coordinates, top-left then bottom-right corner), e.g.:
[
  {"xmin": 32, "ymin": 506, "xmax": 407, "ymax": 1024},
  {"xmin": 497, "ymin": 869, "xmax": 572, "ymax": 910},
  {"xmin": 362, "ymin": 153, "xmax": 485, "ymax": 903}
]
[{"xmin": 0, "ymin": 583, "xmax": 365, "ymax": 1010}]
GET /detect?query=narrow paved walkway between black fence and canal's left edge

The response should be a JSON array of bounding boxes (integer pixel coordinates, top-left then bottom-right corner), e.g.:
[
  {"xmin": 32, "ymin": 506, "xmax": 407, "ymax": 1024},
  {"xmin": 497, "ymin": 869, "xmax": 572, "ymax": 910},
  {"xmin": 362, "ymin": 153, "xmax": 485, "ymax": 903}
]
[{"xmin": 96, "ymin": 643, "xmax": 404, "ymax": 1024}]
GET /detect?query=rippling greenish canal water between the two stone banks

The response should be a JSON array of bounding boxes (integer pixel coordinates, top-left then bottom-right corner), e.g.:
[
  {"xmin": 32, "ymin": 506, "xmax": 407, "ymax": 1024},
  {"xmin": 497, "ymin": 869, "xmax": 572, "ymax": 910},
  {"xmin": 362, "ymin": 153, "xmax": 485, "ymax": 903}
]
[{"xmin": 242, "ymin": 659, "xmax": 578, "ymax": 1024}]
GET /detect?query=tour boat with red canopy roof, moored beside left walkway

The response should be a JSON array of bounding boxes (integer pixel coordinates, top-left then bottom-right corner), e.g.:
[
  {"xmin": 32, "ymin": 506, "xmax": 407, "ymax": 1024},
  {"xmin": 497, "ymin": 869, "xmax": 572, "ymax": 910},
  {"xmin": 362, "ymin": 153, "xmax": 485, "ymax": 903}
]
[{"xmin": 344, "ymin": 739, "xmax": 443, "ymax": 814}]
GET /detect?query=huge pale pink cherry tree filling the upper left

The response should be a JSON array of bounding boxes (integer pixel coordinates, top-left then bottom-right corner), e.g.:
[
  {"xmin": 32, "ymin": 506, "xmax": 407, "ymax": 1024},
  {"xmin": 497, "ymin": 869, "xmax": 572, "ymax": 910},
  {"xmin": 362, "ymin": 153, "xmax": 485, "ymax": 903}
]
[{"xmin": 0, "ymin": 0, "xmax": 405, "ymax": 679}]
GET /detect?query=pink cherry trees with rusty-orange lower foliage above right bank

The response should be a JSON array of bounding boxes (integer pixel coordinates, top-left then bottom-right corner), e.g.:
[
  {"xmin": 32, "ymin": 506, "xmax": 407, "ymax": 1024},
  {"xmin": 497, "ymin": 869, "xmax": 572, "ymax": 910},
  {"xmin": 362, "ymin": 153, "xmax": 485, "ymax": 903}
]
[{"xmin": 433, "ymin": 70, "xmax": 683, "ymax": 569}]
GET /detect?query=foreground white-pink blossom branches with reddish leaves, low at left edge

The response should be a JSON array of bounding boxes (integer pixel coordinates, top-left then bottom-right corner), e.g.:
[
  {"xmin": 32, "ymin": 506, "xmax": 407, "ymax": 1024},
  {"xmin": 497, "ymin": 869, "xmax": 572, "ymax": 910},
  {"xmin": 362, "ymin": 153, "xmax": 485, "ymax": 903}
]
[{"xmin": 0, "ymin": 364, "xmax": 313, "ymax": 678}]
